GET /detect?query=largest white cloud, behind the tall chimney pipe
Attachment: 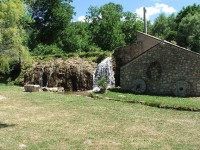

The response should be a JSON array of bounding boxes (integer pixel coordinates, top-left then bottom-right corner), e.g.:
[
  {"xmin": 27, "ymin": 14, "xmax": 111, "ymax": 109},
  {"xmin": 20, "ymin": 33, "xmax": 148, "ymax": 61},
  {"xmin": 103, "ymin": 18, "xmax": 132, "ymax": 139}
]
[{"xmin": 135, "ymin": 3, "xmax": 176, "ymax": 19}]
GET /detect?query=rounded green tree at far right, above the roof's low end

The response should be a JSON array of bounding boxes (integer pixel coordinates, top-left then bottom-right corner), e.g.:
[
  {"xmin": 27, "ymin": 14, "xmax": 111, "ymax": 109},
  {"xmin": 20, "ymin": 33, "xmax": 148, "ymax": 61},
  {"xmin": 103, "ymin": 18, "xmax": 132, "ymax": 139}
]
[{"xmin": 175, "ymin": 4, "xmax": 200, "ymax": 52}]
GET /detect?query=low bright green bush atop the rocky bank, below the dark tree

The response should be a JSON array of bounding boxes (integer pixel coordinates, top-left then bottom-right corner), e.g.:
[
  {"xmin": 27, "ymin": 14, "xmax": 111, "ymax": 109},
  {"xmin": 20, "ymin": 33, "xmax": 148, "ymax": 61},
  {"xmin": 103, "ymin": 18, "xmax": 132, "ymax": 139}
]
[{"xmin": 33, "ymin": 44, "xmax": 63, "ymax": 56}]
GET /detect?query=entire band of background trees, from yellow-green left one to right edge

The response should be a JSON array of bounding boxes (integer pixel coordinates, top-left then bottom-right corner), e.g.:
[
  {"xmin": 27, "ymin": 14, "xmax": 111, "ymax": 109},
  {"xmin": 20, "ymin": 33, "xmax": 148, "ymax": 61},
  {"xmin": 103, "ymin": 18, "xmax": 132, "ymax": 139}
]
[{"xmin": 0, "ymin": 0, "xmax": 200, "ymax": 73}]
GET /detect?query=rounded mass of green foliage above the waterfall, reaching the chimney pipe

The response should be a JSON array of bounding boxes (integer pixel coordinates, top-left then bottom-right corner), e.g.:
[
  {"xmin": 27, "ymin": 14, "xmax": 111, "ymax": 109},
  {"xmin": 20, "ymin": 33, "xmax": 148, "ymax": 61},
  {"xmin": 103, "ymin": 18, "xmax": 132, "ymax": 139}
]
[{"xmin": 86, "ymin": 3, "xmax": 143, "ymax": 51}]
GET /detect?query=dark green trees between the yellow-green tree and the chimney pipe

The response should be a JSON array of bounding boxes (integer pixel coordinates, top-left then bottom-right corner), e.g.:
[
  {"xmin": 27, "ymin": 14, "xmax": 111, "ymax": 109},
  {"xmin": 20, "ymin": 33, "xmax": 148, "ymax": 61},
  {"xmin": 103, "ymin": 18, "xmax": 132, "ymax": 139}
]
[{"xmin": 28, "ymin": 0, "xmax": 142, "ymax": 53}]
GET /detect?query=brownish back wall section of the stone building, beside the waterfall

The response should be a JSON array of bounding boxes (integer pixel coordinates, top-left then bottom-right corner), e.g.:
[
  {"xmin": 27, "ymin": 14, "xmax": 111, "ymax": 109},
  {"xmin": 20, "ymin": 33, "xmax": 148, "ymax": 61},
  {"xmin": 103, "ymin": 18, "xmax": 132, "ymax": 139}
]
[{"xmin": 112, "ymin": 32, "xmax": 161, "ymax": 86}]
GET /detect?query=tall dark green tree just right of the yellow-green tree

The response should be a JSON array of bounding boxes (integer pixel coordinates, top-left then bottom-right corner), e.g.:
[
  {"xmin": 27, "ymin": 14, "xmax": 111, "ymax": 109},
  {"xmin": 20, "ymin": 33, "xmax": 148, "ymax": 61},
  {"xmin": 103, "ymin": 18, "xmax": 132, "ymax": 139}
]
[{"xmin": 29, "ymin": 0, "xmax": 74, "ymax": 47}]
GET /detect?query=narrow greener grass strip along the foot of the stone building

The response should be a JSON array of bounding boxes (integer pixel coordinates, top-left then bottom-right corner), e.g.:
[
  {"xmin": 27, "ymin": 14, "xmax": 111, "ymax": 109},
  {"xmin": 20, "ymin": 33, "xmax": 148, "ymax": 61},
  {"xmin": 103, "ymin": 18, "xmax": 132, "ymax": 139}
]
[{"xmin": 92, "ymin": 89, "xmax": 200, "ymax": 112}]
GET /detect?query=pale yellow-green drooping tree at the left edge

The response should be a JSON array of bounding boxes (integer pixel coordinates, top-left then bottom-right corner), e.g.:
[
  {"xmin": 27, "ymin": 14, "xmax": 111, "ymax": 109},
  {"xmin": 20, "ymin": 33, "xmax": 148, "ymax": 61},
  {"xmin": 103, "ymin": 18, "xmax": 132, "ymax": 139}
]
[{"xmin": 0, "ymin": 0, "xmax": 29, "ymax": 73}]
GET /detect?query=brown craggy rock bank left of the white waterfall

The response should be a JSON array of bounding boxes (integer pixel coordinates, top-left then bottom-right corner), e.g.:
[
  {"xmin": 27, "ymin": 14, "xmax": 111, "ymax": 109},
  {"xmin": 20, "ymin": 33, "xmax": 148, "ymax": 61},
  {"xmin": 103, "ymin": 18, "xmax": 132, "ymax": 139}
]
[{"xmin": 24, "ymin": 57, "xmax": 96, "ymax": 91}]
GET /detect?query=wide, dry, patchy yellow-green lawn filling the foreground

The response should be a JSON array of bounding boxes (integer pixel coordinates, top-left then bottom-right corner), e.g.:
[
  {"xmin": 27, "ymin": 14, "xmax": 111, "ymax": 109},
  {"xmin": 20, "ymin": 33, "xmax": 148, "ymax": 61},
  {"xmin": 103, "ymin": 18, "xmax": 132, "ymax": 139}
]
[{"xmin": 0, "ymin": 85, "xmax": 200, "ymax": 150}]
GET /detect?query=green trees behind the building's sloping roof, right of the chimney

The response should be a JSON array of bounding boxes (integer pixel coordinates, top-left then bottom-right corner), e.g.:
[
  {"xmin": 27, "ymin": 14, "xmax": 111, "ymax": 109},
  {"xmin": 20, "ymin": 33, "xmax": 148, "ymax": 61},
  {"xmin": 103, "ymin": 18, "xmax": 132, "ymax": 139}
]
[{"xmin": 150, "ymin": 4, "xmax": 200, "ymax": 52}]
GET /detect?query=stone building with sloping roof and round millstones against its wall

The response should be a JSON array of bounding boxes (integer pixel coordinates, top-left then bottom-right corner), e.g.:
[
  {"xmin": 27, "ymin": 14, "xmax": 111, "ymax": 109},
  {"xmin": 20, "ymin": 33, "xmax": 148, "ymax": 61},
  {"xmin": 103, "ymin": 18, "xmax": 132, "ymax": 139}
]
[{"xmin": 120, "ymin": 33, "xmax": 200, "ymax": 97}]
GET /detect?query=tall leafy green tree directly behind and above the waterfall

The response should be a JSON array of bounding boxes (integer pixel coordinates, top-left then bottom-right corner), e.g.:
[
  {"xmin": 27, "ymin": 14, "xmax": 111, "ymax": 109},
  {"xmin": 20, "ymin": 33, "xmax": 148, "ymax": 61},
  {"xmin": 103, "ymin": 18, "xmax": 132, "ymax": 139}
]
[{"xmin": 86, "ymin": 3, "xmax": 125, "ymax": 50}]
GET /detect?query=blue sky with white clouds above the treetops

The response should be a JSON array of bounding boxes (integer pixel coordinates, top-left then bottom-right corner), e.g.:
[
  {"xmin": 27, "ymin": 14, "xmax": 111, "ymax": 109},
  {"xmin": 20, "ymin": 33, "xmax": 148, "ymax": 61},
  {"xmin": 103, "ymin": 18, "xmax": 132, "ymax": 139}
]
[{"xmin": 71, "ymin": 0, "xmax": 200, "ymax": 22}]
